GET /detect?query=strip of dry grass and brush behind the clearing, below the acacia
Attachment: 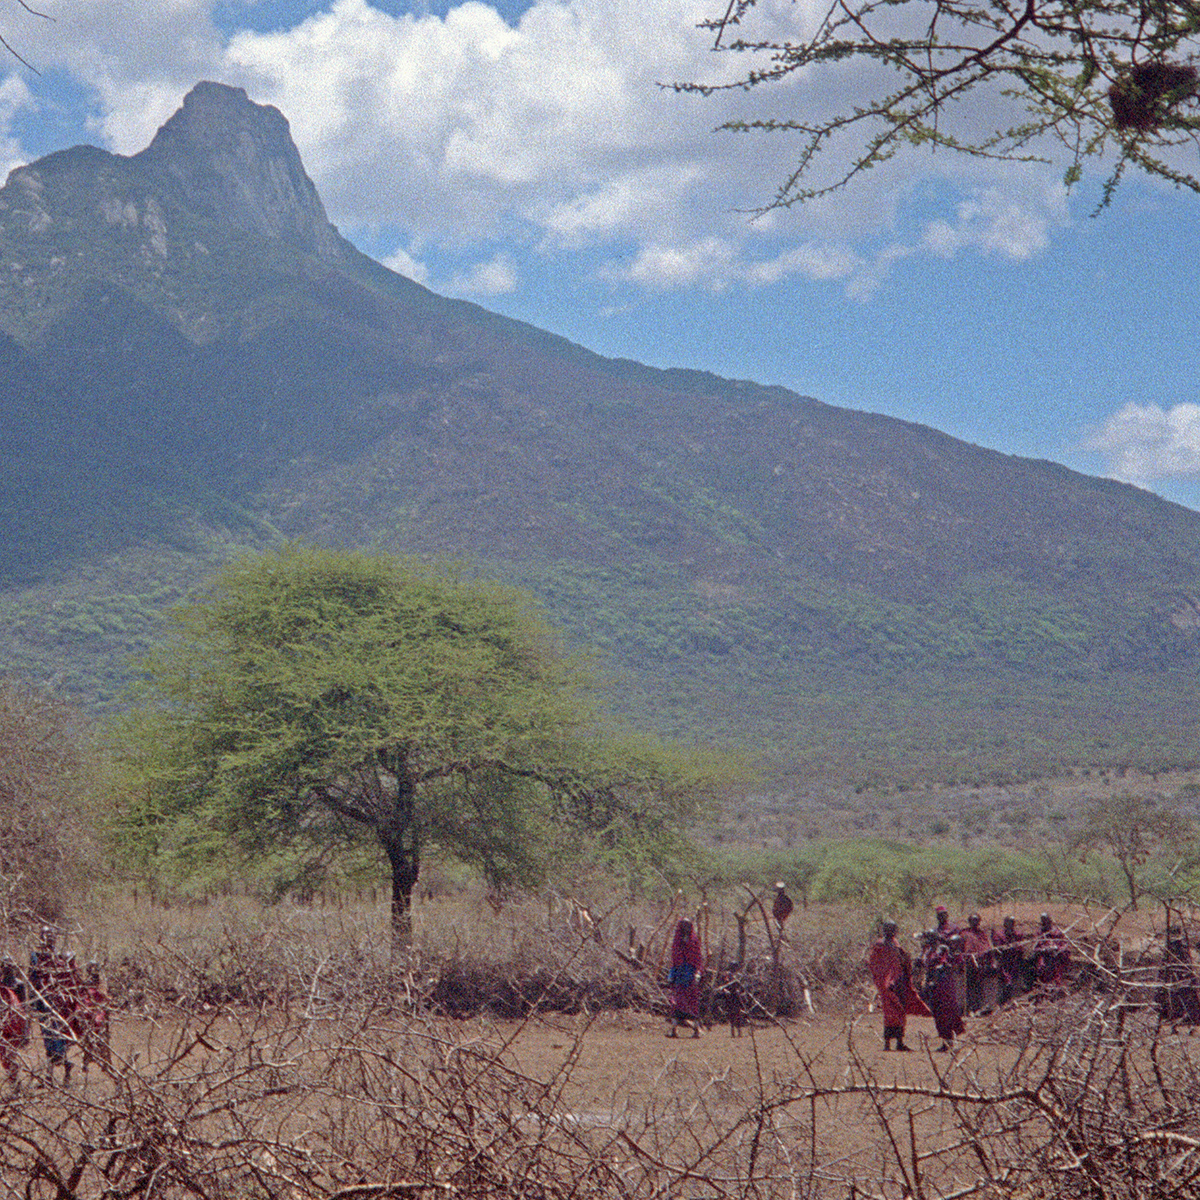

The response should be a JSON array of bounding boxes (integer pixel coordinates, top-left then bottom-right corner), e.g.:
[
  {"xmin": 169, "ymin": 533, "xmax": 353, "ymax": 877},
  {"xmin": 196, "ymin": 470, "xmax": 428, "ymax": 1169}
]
[{"xmin": 4, "ymin": 892, "xmax": 868, "ymax": 1018}]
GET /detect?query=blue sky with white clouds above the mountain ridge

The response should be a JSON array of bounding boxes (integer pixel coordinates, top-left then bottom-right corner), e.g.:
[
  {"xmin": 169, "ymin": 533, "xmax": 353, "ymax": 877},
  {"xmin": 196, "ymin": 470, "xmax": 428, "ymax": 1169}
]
[{"xmin": 0, "ymin": 0, "xmax": 1200, "ymax": 509}]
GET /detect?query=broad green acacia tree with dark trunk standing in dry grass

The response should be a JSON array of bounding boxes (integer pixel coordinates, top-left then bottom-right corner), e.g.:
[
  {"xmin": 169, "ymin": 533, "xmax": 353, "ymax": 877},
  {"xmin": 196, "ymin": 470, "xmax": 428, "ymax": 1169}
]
[{"xmin": 121, "ymin": 546, "xmax": 724, "ymax": 942}]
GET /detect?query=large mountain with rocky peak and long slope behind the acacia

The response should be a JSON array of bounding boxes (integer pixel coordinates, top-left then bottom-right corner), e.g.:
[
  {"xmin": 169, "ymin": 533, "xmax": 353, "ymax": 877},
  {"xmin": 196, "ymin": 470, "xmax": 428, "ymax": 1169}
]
[{"xmin": 0, "ymin": 83, "xmax": 1200, "ymax": 779}]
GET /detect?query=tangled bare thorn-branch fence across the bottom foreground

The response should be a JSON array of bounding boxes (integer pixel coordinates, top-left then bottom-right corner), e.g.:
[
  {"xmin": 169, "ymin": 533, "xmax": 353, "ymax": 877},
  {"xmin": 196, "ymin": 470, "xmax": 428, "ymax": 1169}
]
[{"xmin": 0, "ymin": 974, "xmax": 1200, "ymax": 1200}]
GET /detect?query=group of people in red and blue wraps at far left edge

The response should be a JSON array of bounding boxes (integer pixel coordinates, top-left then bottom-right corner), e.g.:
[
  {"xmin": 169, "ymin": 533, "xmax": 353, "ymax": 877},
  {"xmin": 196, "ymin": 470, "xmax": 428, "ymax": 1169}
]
[{"xmin": 0, "ymin": 925, "xmax": 109, "ymax": 1085}]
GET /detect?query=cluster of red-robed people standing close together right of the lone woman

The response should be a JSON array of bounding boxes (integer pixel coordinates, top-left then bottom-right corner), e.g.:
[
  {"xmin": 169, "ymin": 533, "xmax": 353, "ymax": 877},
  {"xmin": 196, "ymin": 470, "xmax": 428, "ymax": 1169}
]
[{"xmin": 866, "ymin": 905, "xmax": 1070, "ymax": 1052}]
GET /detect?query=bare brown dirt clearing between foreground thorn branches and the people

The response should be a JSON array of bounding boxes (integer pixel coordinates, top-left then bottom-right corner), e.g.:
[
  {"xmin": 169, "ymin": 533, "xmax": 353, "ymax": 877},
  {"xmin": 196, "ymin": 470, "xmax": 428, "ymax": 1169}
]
[{"xmin": 18, "ymin": 996, "xmax": 1200, "ymax": 1200}]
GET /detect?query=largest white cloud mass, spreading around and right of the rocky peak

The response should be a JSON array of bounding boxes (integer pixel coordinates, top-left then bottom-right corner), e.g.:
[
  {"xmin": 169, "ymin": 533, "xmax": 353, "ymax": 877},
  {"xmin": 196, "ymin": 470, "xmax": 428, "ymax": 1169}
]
[{"xmin": 14, "ymin": 0, "xmax": 1080, "ymax": 298}]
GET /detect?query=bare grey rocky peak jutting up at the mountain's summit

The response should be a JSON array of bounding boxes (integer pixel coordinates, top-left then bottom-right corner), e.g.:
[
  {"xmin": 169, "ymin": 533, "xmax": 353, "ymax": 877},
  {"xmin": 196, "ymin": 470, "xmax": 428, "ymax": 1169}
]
[{"xmin": 136, "ymin": 80, "xmax": 341, "ymax": 259}]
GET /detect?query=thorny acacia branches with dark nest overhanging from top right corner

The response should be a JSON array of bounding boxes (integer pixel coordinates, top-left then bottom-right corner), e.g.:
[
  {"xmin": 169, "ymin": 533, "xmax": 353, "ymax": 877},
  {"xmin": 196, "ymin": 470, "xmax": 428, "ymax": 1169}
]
[{"xmin": 676, "ymin": 0, "xmax": 1200, "ymax": 208}]
